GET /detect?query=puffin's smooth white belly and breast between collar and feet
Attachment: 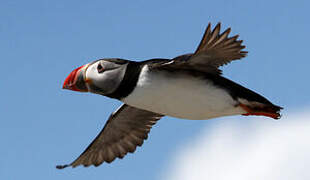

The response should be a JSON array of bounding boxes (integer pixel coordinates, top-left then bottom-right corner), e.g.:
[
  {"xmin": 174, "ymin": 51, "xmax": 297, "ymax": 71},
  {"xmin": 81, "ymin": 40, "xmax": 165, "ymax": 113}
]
[{"xmin": 122, "ymin": 66, "xmax": 245, "ymax": 119}]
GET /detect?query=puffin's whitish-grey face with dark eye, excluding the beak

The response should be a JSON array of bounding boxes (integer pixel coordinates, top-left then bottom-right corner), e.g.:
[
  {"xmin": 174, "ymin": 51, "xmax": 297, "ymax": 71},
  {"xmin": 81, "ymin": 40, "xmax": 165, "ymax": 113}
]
[{"xmin": 85, "ymin": 59, "xmax": 127, "ymax": 95}]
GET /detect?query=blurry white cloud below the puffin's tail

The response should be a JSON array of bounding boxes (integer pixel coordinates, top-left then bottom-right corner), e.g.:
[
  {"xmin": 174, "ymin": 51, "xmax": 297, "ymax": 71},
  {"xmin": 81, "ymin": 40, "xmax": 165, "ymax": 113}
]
[{"xmin": 162, "ymin": 109, "xmax": 310, "ymax": 180}]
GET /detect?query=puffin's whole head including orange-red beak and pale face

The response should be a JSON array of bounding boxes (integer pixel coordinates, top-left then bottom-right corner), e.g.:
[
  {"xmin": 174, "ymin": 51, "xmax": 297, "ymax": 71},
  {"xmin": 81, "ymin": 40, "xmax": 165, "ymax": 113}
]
[{"xmin": 63, "ymin": 59, "xmax": 128, "ymax": 95}]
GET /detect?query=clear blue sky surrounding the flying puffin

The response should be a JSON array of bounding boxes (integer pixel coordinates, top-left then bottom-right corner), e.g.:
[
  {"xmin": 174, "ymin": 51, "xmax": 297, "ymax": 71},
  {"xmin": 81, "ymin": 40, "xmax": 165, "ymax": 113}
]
[{"xmin": 0, "ymin": 0, "xmax": 310, "ymax": 180}]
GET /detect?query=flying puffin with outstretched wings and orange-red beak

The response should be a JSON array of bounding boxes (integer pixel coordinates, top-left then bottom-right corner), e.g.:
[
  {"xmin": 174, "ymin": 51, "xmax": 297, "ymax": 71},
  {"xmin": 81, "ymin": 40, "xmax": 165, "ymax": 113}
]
[{"xmin": 56, "ymin": 23, "xmax": 282, "ymax": 169}]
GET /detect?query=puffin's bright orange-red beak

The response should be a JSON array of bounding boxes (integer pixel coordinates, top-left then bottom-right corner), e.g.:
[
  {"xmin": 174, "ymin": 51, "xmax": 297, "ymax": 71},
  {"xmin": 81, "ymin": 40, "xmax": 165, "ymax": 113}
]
[{"xmin": 62, "ymin": 65, "xmax": 88, "ymax": 92}]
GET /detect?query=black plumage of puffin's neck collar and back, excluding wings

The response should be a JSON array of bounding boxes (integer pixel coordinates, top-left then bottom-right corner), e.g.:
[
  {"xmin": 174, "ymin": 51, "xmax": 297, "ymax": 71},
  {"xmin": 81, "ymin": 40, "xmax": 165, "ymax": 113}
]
[{"xmin": 105, "ymin": 59, "xmax": 272, "ymax": 105}]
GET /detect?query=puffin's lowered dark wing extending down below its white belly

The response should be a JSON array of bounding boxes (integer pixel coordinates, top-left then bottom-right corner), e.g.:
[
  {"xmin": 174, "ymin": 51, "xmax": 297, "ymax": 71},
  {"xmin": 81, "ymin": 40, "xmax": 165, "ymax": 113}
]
[{"xmin": 56, "ymin": 104, "xmax": 163, "ymax": 169}]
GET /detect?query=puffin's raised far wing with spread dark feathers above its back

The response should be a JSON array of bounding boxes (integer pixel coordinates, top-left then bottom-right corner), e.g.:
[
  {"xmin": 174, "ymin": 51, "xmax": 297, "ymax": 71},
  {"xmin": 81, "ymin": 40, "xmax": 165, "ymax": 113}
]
[{"xmin": 156, "ymin": 23, "xmax": 247, "ymax": 74}]
